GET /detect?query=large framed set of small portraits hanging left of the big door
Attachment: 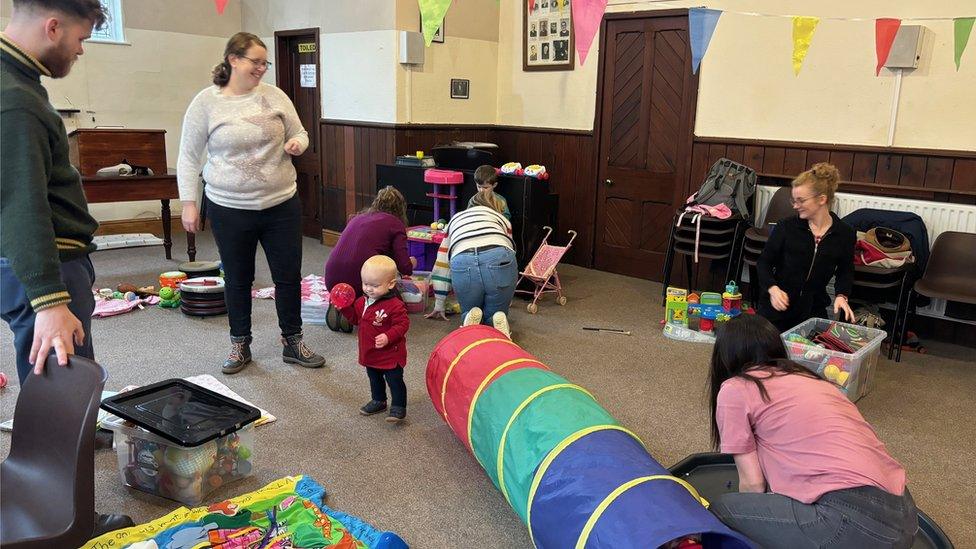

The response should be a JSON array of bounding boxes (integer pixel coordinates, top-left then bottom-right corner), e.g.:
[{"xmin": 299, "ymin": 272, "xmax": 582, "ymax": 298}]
[{"xmin": 524, "ymin": 0, "xmax": 576, "ymax": 70}]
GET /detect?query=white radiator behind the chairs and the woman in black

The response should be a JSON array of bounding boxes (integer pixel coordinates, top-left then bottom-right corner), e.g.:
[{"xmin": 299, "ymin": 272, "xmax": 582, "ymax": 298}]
[{"xmin": 756, "ymin": 185, "xmax": 976, "ymax": 317}]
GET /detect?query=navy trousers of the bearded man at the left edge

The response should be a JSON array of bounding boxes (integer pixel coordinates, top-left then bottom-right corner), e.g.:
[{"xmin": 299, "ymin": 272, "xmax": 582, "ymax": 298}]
[{"xmin": 0, "ymin": 256, "xmax": 95, "ymax": 385}]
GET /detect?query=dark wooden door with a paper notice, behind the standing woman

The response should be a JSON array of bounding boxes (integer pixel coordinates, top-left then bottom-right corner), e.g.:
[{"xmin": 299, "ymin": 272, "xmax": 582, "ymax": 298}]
[{"xmin": 275, "ymin": 29, "xmax": 322, "ymax": 235}]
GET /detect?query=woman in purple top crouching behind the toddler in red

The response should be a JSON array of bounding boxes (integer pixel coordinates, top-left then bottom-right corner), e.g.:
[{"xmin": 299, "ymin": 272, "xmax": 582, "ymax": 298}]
[{"xmin": 325, "ymin": 186, "xmax": 417, "ymax": 324}]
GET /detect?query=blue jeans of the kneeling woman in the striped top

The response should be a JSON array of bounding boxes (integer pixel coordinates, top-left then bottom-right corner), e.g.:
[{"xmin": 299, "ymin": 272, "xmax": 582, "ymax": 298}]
[{"xmin": 451, "ymin": 246, "xmax": 518, "ymax": 326}]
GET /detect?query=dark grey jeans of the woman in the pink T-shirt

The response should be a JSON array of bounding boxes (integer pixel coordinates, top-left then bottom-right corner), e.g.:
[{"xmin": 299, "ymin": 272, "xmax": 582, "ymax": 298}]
[{"xmin": 709, "ymin": 486, "xmax": 918, "ymax": 549}]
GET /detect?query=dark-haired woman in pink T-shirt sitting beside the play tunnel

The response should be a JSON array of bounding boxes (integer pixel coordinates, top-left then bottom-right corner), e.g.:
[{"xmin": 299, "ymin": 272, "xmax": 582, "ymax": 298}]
[{"xmin": 710, "ymin": 315, "xmax": 918, "ymax": 549}]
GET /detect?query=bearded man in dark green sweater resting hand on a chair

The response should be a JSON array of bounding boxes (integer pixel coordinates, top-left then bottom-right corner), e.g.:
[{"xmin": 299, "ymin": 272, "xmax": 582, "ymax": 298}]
[{"xmin": 0, "ymin": 0, "xmax": 105, "ymax": 384}]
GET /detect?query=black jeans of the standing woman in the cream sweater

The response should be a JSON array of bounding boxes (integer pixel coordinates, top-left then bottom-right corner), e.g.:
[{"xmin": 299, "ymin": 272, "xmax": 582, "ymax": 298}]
[{"xmin": 207, "ymin": 193, "xmax": 302, "ymax": 337}]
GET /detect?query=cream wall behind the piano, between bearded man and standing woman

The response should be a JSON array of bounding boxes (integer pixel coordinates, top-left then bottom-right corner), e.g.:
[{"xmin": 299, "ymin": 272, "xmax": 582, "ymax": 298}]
[{"xmin": 0, "ymin": 0, "xmax": 235, "ymax": 221}]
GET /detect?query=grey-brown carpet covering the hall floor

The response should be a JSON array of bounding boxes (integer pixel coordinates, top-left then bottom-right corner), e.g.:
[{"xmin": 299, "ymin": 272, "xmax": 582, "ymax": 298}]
[{"xmin": 0, "ymin": 234, "xmax": 976, "ymax": 548}]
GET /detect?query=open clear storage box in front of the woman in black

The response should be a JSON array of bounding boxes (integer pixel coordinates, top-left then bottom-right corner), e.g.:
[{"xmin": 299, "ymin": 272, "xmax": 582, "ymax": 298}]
[{"xmin": 782, "ymin": 318, "xmax": 887, "ymax": 402}]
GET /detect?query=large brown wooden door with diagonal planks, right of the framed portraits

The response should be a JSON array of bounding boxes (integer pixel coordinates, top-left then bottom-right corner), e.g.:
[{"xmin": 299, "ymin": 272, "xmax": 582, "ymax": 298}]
[{"xmin": 594, "ymin": 11, "xmax": 698, "ymax": 280}]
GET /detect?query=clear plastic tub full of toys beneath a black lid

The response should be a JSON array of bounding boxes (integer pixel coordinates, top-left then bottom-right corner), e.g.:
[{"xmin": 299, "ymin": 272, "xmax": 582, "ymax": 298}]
[{"xmin": 102, "ymin": 416, "xmax": 254, "ymax": 507}]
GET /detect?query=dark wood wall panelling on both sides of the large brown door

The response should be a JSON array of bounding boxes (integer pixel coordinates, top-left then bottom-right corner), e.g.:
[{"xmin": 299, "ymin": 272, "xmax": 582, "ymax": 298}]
[{"xmin": 319, "ymin": 120, "xmax": 976, "ymax": 267}]
